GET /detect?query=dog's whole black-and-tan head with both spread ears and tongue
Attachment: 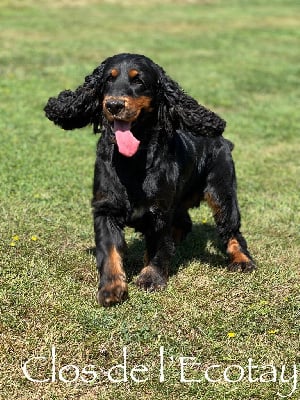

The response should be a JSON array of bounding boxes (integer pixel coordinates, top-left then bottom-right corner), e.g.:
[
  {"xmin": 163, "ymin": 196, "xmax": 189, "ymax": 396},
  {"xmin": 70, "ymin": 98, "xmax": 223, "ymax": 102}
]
[{"xmin": 45, "ymin": 53, "xmax": 225, "ymax": 156}]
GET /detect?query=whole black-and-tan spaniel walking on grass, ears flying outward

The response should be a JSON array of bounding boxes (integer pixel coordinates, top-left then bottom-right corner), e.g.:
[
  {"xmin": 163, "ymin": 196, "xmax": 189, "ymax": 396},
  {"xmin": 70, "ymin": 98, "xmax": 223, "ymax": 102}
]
[{"xmin": 44, "ymin": 53, "xmax": 256, "ymax": 307}]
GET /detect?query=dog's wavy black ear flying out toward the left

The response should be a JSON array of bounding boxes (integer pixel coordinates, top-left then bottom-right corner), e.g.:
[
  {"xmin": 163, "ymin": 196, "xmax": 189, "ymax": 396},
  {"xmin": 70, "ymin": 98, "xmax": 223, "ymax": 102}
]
[{"xmin": 44, "ymin": 60, "xmax": 107, "ymax": 132}]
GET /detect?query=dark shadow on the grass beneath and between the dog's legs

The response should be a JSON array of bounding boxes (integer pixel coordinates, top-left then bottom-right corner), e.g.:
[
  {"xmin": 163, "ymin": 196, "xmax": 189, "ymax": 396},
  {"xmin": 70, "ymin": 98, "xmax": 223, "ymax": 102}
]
[{"xmin": 86, "ymin": 224, "xmax": 226, "ymax": 282}]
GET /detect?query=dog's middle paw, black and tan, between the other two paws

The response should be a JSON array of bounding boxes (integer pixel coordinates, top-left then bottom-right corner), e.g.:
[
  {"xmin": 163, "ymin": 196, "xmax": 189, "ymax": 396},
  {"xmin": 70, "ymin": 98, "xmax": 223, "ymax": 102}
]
[{"xmin": 136, "ymin": 265, "xmax": 167, "ymax": 292}]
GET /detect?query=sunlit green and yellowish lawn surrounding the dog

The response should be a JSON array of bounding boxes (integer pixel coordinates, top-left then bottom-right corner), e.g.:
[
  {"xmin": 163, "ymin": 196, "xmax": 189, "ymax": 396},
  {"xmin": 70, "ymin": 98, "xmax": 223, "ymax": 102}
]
[{"xmin": 0, "ymin": 0, "xmax": 300, "ymax": 400}]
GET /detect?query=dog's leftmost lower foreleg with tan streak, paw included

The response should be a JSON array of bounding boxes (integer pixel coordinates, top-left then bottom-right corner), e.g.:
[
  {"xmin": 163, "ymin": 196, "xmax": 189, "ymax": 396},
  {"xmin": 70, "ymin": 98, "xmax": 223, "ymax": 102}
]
[{"xmin": 94, "ymin": 215, "xmax": 128, "ymax": 307}]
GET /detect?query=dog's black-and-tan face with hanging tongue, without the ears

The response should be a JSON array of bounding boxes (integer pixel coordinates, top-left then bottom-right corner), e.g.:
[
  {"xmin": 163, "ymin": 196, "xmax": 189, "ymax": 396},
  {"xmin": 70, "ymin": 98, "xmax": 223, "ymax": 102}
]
[{"xmin": 101, "ymin": 54, "xmax": 158, "ymax": 157}]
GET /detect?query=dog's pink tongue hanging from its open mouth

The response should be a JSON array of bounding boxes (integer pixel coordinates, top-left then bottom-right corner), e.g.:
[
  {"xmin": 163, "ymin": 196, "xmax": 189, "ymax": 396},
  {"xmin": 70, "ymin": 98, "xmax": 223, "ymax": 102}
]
[{"xmin": 114, "ymin": 121, "xmax": 140, "ymax": 157}]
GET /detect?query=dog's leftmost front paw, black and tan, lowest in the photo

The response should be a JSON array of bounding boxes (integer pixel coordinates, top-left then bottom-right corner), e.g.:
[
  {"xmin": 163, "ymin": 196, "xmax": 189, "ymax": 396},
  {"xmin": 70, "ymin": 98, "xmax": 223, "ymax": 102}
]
[{"xmin": 97, "ymin": 278, "xmax": 128, "ymax": 307}]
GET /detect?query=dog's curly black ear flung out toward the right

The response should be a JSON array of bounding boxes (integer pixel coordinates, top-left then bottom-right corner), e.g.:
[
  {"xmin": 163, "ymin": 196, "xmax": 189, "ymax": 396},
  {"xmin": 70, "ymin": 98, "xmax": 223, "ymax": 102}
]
[{"xmin": 156, "ymin": 65, "xmax": 226, "ymax": 137}]
